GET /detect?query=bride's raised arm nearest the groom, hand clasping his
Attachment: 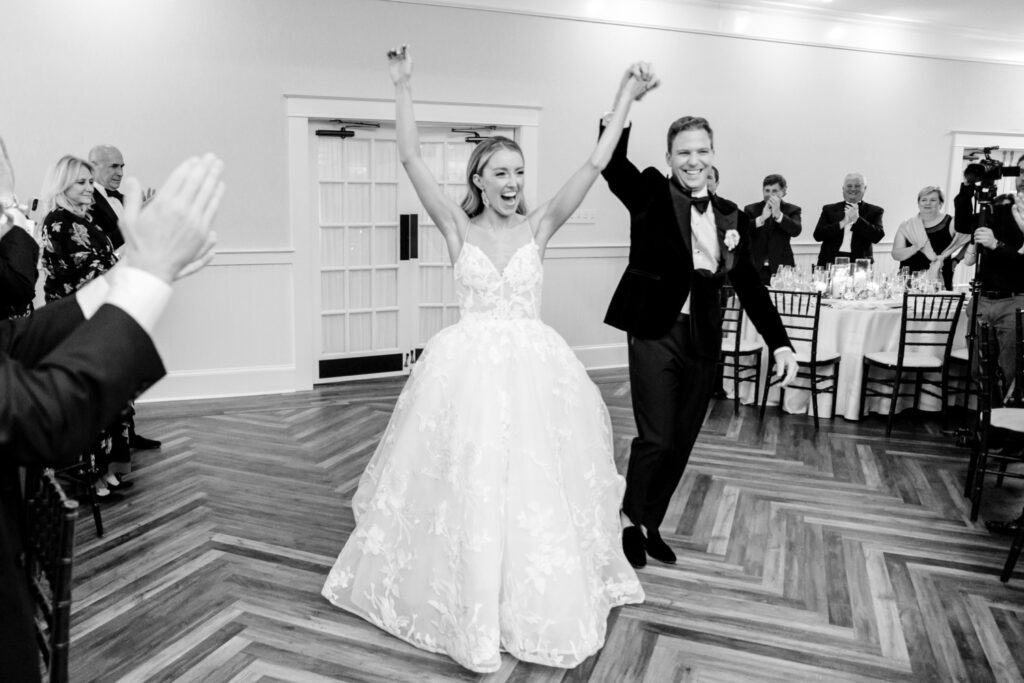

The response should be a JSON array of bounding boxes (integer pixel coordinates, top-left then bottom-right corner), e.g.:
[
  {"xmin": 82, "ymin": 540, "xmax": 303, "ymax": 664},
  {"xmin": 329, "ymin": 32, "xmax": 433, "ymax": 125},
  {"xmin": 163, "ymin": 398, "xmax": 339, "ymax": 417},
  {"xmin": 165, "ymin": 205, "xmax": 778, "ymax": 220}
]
[{"xmin": 530, "ymin": 61, "xmax": 658, "ymax": 249}]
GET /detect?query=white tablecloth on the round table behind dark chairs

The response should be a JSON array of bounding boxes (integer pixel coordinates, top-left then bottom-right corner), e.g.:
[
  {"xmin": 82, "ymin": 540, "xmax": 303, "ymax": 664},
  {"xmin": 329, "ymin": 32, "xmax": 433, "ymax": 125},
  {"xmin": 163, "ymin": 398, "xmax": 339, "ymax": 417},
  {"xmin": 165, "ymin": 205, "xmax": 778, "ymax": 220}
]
[{"xmin": 725, "ymin": 301, "xmax": 967, "ymax": 420}]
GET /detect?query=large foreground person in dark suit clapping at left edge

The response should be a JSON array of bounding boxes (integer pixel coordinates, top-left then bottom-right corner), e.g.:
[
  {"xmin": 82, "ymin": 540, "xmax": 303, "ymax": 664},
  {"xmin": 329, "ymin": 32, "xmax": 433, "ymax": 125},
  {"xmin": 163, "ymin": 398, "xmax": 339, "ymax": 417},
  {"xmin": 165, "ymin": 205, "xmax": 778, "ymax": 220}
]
[{"xmin": 0, "ymin": 148, "xmax": 223, "ymax": 683}]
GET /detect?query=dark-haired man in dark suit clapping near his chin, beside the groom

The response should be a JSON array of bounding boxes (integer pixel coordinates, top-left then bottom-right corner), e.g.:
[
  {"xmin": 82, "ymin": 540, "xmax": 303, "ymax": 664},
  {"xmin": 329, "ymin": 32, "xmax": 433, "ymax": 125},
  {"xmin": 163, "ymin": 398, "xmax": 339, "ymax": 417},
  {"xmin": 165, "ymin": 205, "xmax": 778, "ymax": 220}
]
[{"xmin": 743, "ymin": 173, "xmax": 803, "ymax": 285}]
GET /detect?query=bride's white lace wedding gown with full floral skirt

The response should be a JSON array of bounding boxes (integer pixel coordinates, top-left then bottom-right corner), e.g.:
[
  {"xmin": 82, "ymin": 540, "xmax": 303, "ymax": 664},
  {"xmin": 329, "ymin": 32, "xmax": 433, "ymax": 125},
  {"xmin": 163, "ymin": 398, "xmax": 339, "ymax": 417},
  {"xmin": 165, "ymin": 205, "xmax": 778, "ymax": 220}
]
[{"xmin": 323, "ymin": 233, "xmax": 644, "ymax": 673}]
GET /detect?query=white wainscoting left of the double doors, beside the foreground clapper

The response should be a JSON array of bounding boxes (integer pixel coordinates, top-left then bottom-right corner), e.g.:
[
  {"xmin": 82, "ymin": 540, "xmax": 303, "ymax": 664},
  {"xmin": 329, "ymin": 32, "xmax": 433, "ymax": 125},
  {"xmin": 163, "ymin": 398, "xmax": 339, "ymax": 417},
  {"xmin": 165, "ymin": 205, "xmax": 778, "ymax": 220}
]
[{"xmin": 140, "ymin": 250, "xmax": 302, "ymax": 401}]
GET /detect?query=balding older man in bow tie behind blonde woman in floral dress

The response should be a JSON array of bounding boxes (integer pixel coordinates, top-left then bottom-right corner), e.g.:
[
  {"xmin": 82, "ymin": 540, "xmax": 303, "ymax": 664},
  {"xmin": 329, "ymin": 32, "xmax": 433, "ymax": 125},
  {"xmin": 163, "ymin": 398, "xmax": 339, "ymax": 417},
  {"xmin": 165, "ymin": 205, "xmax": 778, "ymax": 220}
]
[{"xmin": 89, "ymin": 144, "xmax": 160, "ymax": 454}]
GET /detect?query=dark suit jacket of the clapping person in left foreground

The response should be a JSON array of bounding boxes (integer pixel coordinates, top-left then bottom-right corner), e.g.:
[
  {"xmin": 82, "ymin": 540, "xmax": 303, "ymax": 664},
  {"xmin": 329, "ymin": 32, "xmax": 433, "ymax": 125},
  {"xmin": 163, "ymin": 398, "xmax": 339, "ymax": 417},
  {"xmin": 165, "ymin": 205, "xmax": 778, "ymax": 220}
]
[{"xmin": 0, "ymin": 296, "xmax": 164, "ymax": 681}]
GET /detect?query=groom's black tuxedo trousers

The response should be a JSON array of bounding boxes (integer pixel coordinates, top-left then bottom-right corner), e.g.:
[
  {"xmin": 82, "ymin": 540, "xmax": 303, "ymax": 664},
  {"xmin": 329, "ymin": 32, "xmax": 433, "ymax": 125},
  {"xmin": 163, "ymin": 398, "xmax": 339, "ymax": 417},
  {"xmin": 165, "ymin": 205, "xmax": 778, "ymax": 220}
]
[{"xmin": 623, "ymin": 315, "xmax": 717, "ymax": 529}]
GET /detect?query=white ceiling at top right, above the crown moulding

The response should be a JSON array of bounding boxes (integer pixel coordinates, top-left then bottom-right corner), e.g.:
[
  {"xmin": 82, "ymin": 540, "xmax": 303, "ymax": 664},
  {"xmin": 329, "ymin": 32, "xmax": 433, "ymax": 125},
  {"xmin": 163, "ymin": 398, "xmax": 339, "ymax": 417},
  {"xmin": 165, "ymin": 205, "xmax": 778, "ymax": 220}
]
[{"xmin": 395, "ymin": 0, "xmax": 1024, "ymax": 66}]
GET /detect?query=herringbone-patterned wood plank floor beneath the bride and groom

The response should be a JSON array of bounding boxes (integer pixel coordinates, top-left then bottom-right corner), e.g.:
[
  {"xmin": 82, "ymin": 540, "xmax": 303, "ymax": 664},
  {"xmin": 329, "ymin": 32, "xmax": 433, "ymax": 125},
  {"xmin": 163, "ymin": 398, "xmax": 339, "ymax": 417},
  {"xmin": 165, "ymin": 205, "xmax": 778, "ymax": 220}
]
[{"xmin": 66, "ymin": 372, "xmax": 1024, "ymax": 683}]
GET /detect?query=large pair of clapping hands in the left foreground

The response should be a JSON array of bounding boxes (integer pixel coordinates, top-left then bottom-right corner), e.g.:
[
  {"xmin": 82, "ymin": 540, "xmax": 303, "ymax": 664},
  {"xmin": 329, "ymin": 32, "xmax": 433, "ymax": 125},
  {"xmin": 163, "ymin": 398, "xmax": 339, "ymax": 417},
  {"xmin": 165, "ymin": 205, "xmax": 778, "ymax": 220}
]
[{"xmin": 119, "ymin": 155, "xmax": 224, "ymax": 283}]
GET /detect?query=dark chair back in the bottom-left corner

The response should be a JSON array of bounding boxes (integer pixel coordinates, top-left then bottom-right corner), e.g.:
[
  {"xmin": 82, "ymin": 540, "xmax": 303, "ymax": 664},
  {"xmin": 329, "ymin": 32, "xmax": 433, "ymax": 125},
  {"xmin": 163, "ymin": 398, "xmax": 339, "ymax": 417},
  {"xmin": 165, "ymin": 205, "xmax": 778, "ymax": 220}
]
[{"xmin": 26, "ymin": 469, "xmax": 78, "ymax": 682}]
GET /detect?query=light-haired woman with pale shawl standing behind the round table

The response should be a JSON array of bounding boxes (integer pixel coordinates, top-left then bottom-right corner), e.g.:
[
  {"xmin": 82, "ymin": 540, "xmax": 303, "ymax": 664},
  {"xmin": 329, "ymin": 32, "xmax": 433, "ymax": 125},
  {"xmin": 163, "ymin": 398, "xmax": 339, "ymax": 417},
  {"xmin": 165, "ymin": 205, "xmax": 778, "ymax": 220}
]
[{"xmin": 893, "ymin": 185, "xmax": 970, "ymax": 290}]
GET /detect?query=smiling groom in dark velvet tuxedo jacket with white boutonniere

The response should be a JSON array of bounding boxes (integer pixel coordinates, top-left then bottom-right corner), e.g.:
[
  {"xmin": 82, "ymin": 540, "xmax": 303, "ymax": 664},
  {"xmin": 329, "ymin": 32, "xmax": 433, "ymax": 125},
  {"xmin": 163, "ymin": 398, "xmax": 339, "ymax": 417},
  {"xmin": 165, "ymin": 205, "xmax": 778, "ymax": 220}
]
[{"xmin": 602, "ymin": 117, "xmax": 797, "ymax": 567}]
